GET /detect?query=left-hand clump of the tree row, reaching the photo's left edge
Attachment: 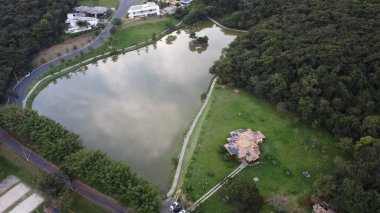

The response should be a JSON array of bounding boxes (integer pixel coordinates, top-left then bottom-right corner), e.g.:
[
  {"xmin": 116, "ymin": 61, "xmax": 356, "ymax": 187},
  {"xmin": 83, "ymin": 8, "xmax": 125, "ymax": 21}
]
[{"xmin": 0, "ymin": 106, "xmax": 83, "ymax": 164}]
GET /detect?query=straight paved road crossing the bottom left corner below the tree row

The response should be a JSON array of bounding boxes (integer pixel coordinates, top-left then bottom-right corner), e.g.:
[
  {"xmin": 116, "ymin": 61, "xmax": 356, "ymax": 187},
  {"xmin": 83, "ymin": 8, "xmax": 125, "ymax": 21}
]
[{"xmin": 0, "ymin": 129, "xmax": 128, "ymax": 213}]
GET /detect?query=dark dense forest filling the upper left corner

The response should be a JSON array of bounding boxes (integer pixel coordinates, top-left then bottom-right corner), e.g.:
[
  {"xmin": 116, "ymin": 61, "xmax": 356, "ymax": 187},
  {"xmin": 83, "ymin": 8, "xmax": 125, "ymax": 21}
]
[{"xmin": 0, "ymin": 0, "xmax": 77, "ymax": 102}]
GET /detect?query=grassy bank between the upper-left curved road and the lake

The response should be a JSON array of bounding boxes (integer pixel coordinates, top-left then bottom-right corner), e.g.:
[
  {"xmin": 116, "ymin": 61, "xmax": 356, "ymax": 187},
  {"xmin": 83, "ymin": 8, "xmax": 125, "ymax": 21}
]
[{"xmin": 26, "ymin": 17, "xmax": 180, "ymax": 108}]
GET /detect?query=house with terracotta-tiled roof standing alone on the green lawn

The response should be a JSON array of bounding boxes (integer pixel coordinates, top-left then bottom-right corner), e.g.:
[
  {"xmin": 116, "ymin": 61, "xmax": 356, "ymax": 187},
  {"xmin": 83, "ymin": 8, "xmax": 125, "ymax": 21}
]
[{"xmin": 224, "ymin": 129, "xmax": 265, "ymax": 163}]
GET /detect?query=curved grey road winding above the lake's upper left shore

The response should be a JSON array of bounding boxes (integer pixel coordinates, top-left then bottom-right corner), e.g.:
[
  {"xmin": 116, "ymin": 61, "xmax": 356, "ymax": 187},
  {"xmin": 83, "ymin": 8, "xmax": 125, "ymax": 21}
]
[{"xmin": 9, "ymin": 0, "xmax": 138, "ymax": 108}]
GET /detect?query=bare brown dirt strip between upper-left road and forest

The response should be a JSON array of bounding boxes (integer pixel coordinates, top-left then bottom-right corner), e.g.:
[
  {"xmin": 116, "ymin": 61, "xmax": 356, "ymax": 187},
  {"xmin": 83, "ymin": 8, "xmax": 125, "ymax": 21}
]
[{"xmin": 32, "ymin": 32, "xmax": 96, "ymax": 68}]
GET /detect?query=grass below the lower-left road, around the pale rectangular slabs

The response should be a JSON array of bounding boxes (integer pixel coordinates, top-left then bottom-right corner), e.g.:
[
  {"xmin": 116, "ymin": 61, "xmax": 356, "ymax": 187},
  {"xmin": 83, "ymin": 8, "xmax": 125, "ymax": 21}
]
[{"xmin": 0, "ymin": 141, "xmax": 106, "ymax": 213}]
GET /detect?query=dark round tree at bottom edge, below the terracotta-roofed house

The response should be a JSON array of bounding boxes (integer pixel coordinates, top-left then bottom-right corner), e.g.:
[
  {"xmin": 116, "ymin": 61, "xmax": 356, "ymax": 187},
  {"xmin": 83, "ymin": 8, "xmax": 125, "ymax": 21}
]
[{"xmin": 220, "ymin": 178, "xmax": 264, "ymax": 213}]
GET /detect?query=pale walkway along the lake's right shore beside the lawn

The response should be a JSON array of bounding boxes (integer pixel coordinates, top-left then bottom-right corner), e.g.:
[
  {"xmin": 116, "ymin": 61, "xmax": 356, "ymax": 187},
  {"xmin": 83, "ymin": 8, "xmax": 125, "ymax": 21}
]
[{"xmin": 166, "ymin": 78, "xmax": 217, "ymax": 197}]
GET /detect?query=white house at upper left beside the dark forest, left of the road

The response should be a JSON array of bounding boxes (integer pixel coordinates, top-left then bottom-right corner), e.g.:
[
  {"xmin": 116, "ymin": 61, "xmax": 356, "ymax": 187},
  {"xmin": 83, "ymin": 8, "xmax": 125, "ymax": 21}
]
[{"xmin": 65, "ymin": 13, "xmax": 99, "ymax": 33}]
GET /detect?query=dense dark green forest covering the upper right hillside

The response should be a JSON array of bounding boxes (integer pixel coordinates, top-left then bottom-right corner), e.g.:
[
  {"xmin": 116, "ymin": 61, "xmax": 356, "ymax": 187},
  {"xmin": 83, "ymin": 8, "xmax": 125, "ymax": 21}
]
[{"xmin": 210, "ymin": 0, "xmax": 380, "ymax": 139}]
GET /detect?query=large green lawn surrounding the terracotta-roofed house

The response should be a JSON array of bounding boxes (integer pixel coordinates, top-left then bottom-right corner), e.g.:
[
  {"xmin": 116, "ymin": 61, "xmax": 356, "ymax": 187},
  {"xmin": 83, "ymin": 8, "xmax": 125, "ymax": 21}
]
[{"xmin": 182, "ymin": 86, "xmax": 348, "ymax": 212}]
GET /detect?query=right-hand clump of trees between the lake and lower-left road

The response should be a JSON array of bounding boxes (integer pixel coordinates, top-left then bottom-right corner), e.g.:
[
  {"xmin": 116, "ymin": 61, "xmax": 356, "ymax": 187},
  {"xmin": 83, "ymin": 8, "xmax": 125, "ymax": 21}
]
[{"xmin": 62, "ymin": 149, "xmax": 160, "ymax": 212}]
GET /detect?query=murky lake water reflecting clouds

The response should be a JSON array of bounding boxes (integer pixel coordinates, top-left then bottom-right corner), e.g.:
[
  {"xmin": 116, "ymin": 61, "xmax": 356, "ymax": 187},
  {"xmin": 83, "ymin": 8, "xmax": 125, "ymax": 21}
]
[{"xmin": 33, "ymin": 22, "xmax": 237, "ymax": 190}]
